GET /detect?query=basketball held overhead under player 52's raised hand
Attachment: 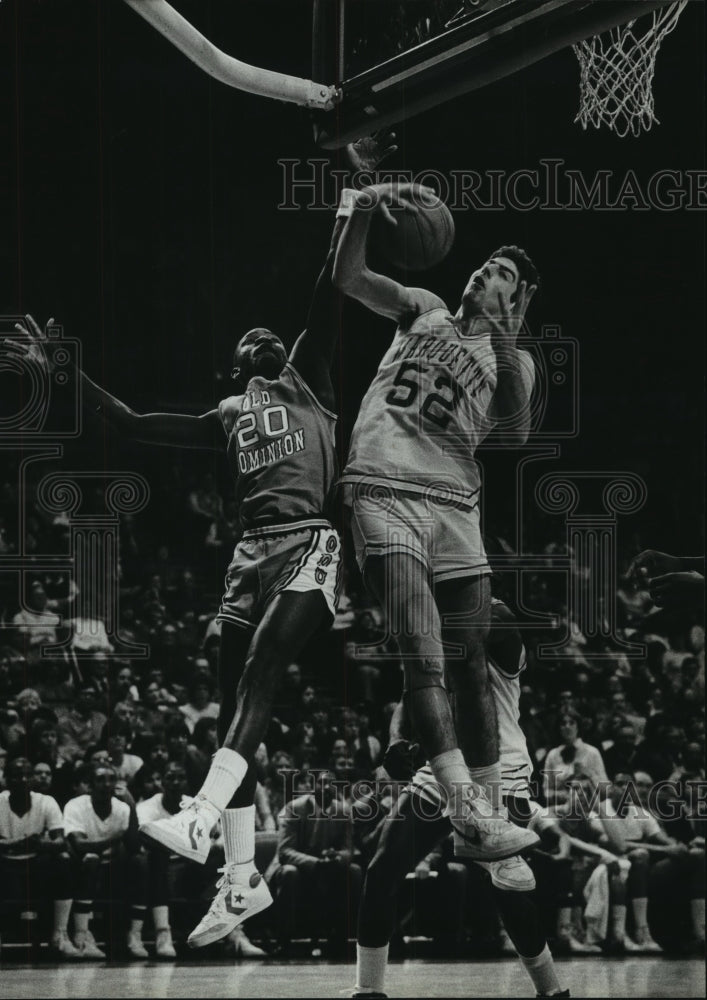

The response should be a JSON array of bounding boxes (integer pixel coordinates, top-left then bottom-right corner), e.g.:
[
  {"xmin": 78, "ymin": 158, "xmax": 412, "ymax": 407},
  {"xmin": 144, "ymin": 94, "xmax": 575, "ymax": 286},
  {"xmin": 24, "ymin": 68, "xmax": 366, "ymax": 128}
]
[{"xmin": 371, "ymin": 185, "xmax": 454, "ymax": 271}]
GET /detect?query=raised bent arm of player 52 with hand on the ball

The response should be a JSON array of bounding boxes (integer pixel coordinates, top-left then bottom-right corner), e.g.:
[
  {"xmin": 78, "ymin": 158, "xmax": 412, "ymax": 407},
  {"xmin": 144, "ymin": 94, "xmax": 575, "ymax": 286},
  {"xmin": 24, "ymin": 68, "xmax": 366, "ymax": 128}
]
[{"xmin": 334, "ymin": 184, "xmax": 444, "ymax": 323}]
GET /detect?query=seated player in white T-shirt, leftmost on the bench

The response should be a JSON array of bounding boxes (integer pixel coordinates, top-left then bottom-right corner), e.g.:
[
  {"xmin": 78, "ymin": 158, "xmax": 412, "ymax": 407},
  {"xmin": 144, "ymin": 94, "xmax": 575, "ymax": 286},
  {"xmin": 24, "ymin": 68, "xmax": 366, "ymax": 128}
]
[{"xmin": 0, "ymin": 757, "xmax": 79, "ymax": 959}]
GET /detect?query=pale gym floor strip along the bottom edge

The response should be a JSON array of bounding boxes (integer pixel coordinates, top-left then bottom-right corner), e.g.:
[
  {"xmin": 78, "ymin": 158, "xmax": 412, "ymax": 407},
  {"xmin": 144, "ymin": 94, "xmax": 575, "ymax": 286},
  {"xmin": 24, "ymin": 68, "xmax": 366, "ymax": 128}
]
[{"xmin": 0, "ymin": 956, "xmax": 705, "ymax": 1000}]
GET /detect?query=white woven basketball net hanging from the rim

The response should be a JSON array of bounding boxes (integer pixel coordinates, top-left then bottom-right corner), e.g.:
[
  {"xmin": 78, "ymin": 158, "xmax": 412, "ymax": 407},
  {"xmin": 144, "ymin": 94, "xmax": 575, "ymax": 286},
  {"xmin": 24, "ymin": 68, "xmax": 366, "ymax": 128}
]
[{"xmin": 572, "ymin": 0, "xmax": 687, "ymax": 138}]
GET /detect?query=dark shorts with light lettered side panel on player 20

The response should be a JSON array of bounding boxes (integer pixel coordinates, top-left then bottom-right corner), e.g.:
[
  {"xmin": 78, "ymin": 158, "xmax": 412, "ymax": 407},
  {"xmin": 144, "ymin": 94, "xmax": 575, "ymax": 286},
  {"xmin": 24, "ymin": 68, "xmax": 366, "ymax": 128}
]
[{"xmin": 217, "ymin": 521, "xmax": 341, "ymax": 628}]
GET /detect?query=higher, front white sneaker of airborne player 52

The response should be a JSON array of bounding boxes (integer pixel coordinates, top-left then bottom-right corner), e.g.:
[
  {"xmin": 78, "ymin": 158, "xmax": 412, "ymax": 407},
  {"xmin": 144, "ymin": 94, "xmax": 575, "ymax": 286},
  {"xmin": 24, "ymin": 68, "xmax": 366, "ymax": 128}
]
[{"xmin": 446, "ymin": 782, "xmax": 540, "ymax": 861}]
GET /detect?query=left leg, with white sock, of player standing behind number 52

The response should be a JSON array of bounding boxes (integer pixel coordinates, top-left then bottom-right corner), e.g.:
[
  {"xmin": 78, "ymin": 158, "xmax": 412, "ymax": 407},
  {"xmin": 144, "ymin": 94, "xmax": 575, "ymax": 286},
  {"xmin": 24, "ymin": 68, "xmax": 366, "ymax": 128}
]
[{"xmin": 352, "ymin": 790, "xmax": 449, "ymax": 996}]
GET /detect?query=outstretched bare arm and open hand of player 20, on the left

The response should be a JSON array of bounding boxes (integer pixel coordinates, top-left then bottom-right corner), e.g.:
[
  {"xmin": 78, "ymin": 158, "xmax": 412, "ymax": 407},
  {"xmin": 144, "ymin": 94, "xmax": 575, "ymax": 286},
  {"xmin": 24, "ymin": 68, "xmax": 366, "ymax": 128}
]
[{"xmin": 13, "ymin": 315, "xmax": 224, "ymax": 450}]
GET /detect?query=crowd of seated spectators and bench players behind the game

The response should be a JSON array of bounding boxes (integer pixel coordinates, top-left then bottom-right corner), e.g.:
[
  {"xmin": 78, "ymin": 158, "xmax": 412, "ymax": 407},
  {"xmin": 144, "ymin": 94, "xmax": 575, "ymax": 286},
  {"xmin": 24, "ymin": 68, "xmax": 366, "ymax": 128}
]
[{"xmin": 0, "ymin": 460, "xmax": 705, "ymax": 959}]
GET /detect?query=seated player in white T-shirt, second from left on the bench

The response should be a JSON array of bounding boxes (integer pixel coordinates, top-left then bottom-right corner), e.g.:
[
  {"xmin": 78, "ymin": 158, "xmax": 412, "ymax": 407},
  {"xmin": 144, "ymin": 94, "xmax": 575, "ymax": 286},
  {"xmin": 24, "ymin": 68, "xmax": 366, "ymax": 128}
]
[{"xmin": 64, "ymin": 764, "xmax": 147, "ymax": 959}]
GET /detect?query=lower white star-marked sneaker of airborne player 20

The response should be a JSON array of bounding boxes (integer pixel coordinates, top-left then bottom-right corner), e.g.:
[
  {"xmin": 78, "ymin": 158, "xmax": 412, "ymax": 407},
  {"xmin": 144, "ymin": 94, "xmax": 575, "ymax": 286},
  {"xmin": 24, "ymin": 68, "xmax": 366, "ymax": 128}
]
[{"xmin": 187, "ymin": 863, "xmax": 272, "ymax": 948}]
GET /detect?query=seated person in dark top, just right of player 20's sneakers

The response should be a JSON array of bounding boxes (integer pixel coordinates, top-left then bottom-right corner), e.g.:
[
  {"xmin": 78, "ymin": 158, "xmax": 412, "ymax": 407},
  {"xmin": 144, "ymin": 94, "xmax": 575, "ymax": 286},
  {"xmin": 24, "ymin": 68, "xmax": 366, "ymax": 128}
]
[{"xmin": 266, "ymin": 771, "xmax": 362, "ymax": 952}]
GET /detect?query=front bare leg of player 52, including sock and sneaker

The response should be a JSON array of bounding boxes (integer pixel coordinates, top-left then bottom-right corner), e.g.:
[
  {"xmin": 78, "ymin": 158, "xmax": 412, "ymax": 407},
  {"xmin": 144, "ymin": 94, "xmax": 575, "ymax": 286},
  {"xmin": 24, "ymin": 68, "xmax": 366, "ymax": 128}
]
[{"xmin": 365, "ymin": 552, "xmax": 538, "ymax": 861}]
